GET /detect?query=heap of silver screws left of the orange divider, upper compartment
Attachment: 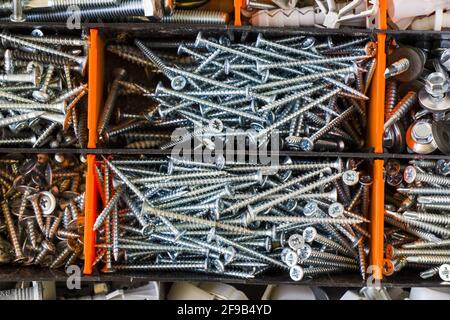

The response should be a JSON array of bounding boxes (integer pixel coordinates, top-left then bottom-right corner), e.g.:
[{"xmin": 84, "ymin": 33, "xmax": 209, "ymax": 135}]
[{"xmin": 0, "ymin": 31, "xmax": 88, "ymax": 148}]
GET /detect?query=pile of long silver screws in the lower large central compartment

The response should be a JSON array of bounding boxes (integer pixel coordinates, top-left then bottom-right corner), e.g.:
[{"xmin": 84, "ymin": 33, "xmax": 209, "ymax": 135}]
[{"xmin": 94, "ymin": 157, "xmax": 372, "ymax": 281}]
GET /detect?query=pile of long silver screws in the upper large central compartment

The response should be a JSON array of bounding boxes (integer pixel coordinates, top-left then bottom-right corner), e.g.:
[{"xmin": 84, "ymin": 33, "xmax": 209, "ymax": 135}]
[{"xmin": 98, "ymin": 33, "xmax": 376, "ymax": 151}]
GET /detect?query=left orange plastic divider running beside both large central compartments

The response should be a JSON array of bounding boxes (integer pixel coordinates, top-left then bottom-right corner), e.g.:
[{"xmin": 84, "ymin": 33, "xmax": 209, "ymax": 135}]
[{"xmin": 84, "ymin": 29, "xmax": 104, "ymax": 274}]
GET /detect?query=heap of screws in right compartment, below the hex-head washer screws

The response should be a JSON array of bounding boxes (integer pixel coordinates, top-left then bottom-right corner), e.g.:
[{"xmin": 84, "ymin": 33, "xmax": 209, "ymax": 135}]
[{"xmin": 385, "ymin": 160, "xmax": 450, "ymax": 279}]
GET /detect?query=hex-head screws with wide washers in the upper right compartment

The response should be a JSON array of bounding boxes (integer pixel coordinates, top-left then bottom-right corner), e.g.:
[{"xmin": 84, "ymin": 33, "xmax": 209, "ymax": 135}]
[{"xmin": 384, "ymin": 46, "xmax": 450, "ymax": 155}]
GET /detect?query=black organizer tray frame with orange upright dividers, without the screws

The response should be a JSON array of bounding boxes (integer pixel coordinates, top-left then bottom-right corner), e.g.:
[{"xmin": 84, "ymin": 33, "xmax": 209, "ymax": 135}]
[{"xmin": 0, "ymin": 0, "xmax": 448, "ymax": 287}]
